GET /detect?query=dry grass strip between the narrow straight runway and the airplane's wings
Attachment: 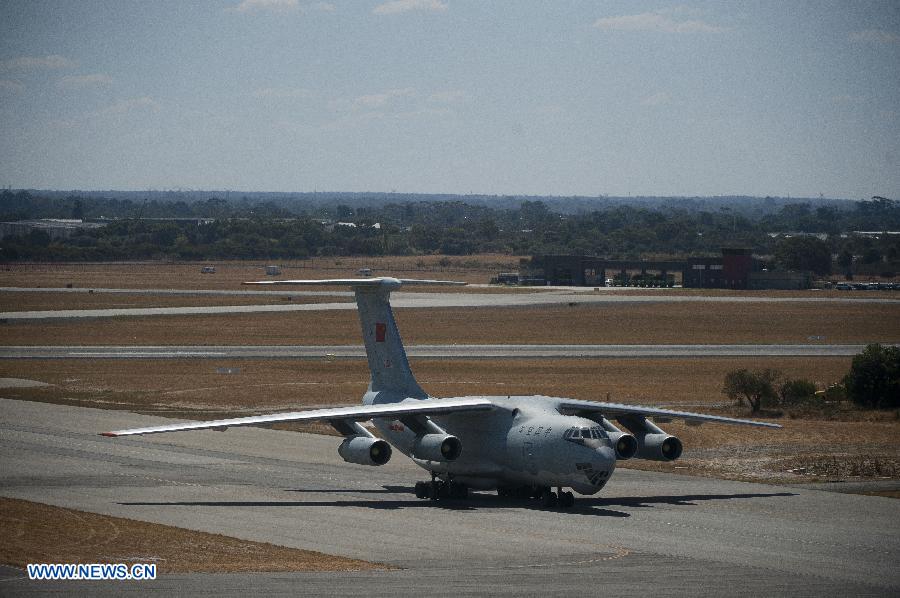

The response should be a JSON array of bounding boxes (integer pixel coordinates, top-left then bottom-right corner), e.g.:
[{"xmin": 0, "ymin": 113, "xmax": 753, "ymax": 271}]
[{"xmin": 0, "ymin": 357, "xmax": 850, "ymax": 418}]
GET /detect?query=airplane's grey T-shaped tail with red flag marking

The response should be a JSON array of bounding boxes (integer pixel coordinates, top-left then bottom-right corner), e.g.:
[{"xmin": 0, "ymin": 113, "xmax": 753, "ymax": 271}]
[{"xmin": 245, "ymin": 277, "xmax": 466, "ymax": 400}]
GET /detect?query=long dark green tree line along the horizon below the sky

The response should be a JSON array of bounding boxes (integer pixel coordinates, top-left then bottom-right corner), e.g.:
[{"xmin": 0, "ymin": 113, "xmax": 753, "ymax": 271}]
[{"xmin": 0, "ymin": 191, "xmax": 900, "ymax": 275}]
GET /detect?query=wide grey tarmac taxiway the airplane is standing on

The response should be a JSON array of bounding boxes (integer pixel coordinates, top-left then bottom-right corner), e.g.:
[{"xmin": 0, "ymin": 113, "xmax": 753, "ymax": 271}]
[{"xmin": 0, "ymin": 400, "xmax": 900, "ymax": 596}]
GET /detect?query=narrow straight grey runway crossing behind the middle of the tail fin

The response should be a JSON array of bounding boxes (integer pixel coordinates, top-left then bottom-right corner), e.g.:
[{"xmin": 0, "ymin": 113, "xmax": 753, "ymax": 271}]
[{"xmin": 0, "ymin": 344, "xmax": 865, "ymax": 359}]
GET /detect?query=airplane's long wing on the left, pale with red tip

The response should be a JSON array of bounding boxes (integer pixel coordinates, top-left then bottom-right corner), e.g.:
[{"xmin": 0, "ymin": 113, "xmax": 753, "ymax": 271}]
[{"xmin": 100, "ymin": 397, "xmax": 495, "ymax": 437}]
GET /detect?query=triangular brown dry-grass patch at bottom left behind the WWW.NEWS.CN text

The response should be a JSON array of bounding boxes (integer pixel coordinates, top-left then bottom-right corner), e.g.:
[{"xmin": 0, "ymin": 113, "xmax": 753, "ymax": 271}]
[{"xmin": 0, "ymin": 497, "xmax": 391, "ymax": 575}]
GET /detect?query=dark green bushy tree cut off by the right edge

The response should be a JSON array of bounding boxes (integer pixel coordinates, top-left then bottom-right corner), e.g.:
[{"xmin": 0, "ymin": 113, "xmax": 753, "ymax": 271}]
[{"xmin": 844, "ymin": 344, "xmax": 900, "ymax": 409}]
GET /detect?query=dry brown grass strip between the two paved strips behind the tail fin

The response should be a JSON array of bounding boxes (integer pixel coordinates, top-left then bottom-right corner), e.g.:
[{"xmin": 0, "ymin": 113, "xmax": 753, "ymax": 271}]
[{"xmin": 0, "ymin": 297, "xmax": 900, "ymax": 345}]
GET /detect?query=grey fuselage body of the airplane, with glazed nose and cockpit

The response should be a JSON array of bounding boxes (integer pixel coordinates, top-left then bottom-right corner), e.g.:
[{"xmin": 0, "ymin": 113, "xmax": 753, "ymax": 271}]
[{"xmin": 364, "ymin": 392, "xmax": 616, "ymax": 494}]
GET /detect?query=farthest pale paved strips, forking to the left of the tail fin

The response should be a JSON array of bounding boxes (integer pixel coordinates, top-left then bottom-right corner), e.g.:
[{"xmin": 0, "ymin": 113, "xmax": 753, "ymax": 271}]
[{"xmin": 0, "ymin": 287, "xmax": 900, "ymax": 322}]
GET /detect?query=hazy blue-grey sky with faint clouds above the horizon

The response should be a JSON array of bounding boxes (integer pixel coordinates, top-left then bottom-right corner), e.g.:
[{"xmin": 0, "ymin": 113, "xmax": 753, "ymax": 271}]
[{"xmin": 0, "ymin": 0, "xmax": 900, "ymax": 199}]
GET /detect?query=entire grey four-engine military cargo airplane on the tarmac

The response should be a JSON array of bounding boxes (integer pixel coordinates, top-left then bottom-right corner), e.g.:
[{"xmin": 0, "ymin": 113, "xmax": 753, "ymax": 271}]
[{"xmin": 101, "ymin": 277, "xmax": 781, "ymax": 509}]
